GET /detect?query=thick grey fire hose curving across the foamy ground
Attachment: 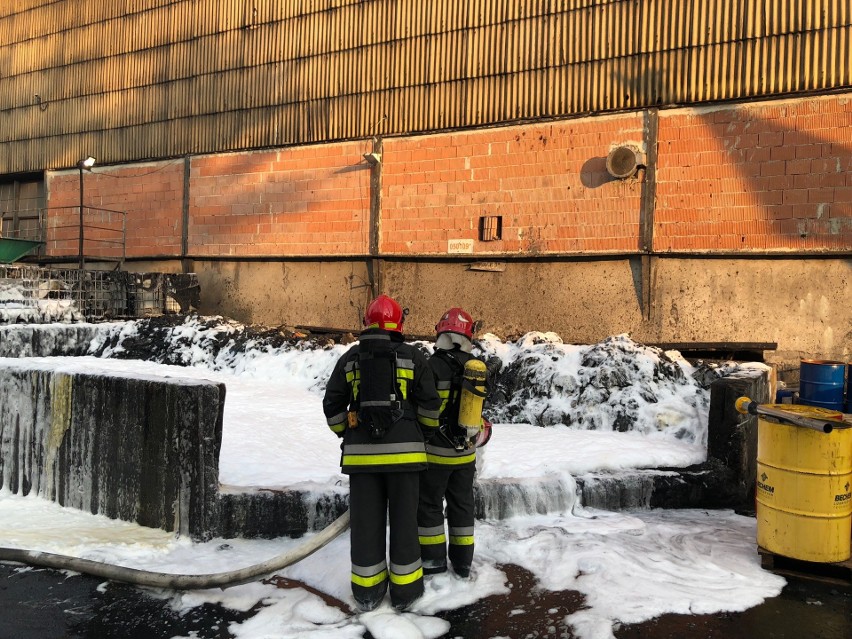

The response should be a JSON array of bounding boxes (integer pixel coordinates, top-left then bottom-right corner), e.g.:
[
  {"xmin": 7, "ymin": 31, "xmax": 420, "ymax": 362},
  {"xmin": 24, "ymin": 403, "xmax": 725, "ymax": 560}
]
[{"xmin": 0, "ymin": 510, "xmax": 349, "ymax": 590}]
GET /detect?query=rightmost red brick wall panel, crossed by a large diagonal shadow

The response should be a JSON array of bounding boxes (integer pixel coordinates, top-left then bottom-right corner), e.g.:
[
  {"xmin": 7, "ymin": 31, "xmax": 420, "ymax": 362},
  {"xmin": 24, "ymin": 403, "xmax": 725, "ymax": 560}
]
[{"xmin": 654, "ymin": 96, "xmax": 852, "ymax": 251}]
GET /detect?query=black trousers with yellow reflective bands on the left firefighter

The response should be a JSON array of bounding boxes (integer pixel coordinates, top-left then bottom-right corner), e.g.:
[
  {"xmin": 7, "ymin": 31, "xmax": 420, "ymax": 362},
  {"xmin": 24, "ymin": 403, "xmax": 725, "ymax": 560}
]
[{"xmin": 349, "ymin": 471, "xmax": 423, "ymax": 610}]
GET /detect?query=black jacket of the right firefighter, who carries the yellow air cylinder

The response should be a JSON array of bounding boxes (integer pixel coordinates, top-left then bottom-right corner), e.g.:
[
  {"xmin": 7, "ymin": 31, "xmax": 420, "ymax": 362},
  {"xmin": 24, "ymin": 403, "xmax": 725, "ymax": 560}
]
[{"xmin": 426, "ymin": 348, "xmax": 486, "ymax": 468}]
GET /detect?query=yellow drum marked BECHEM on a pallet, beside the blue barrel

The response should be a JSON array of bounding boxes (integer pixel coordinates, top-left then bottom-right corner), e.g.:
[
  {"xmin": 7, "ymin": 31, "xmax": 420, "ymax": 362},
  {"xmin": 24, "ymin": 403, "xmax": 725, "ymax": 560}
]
[{"xmin": 756, "ymin": 404, "xmax": 852, "ymax": 563}]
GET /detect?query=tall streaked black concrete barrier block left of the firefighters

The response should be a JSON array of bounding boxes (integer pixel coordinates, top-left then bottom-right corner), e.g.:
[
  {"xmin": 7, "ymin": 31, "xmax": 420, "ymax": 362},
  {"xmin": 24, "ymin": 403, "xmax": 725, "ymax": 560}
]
[{"xmin": 0, "ymin": 359, "xmax": 225, "ymax": 540}]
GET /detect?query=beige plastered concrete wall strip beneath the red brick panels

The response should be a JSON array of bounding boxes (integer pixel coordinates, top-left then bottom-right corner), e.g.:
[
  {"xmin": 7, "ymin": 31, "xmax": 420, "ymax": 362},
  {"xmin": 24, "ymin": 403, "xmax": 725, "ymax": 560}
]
[{"xmin": 188, "ymin": 256, "xmax": 852, "ymax": 382}]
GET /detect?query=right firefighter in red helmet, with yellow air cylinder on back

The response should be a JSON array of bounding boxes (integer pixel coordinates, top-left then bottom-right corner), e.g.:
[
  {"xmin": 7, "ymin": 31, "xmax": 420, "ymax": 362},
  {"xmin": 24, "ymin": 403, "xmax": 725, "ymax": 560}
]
[{"xmin": 417, "ymin": 308, "xmax": 491, "ymax": 578}]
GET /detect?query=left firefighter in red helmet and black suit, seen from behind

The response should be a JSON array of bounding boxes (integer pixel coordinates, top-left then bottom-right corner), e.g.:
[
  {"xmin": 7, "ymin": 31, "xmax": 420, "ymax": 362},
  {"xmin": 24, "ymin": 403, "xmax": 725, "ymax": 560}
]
[{"xmin": 323, "ymin": 295, "xmax": 441, "ymax": 611}]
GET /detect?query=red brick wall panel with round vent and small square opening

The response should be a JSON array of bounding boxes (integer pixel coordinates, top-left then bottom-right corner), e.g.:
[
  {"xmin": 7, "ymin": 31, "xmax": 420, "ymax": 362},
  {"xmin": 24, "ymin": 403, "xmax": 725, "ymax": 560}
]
[{"xmin": 381, "ymin": 115, "xmax": 642, "ymax": 254}]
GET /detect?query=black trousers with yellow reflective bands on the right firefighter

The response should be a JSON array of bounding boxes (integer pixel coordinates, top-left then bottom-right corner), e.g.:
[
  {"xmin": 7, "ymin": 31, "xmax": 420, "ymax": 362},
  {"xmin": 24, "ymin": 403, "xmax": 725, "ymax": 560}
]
[{"xmin": 417, "ymin": 464, "xmax": 476, "ymax": 577}]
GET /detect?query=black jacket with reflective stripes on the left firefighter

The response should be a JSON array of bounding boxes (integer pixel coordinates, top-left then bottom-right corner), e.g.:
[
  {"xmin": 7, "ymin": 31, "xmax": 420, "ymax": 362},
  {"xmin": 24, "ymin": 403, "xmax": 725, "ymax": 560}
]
[{"xmin": 323, "ymin": 329, "xmax": 441, "ymax": 474}]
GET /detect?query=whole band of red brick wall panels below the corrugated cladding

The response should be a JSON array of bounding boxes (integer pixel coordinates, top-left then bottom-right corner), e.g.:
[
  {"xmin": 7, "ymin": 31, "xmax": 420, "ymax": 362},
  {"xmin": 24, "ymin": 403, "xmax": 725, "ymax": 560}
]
[{"xmin": 48, "ymin": 95, "xmax": 852, "ymax": 258}]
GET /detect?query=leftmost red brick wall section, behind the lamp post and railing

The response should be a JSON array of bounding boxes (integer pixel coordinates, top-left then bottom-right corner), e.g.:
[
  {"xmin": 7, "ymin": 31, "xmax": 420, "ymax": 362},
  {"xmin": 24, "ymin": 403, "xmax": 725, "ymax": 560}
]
[{"xmin": 47, "ymin": 160, "xmax": 184, "ymax": 257}]
